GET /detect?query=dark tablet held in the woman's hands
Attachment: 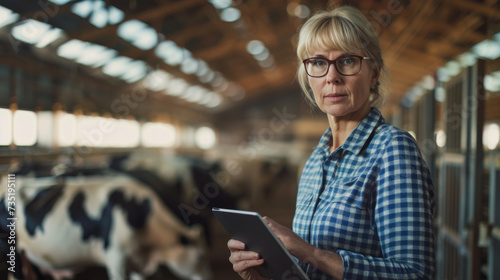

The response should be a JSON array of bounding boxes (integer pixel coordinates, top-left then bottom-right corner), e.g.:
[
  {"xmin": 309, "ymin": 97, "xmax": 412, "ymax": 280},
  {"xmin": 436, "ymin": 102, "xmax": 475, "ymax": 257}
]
[{"xmin": 212, "ymin": 208, "xmax": 309, "ymax": 280}]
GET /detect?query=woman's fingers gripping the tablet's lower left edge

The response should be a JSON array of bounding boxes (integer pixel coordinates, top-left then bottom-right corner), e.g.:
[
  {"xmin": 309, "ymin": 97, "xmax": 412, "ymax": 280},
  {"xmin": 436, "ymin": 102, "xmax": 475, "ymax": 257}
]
[{"xmin": 227, "ymin": 239, "xmax": 266, "ymax": 280}]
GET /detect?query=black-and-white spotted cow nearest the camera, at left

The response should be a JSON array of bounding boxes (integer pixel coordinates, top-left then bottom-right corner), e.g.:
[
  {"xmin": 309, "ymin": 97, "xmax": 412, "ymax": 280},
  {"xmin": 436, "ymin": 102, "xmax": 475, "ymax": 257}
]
[{"xmin": 0, "ymin": 172, "xmax": 211, "ymax": 280}]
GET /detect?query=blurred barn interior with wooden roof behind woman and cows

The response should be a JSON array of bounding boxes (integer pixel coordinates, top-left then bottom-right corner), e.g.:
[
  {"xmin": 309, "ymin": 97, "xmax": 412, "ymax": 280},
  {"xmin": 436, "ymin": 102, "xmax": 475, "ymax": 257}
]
[{"xmin": 0, "ymin": 0, "xmax": 500, "ymax": 279}]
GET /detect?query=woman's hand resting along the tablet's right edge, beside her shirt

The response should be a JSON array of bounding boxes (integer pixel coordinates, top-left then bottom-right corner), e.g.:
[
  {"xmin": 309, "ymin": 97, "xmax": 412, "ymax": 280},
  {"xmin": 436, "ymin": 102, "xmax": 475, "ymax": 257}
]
[{"xmin": 264, "ymin": 217, "xmax": 316, "ymax": 261}]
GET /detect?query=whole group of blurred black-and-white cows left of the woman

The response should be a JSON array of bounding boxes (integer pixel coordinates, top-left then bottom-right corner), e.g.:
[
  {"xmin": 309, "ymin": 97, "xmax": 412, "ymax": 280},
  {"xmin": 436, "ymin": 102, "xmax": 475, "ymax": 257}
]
[{"xmin": 0, "ymin": 154, "xmax": 262, "ymax": 280}]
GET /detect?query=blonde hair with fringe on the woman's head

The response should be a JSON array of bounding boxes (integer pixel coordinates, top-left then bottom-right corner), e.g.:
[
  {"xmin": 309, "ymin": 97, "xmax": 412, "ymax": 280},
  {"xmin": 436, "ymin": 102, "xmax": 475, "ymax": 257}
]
[{"xmin": 297, "ymin": 6, "xmax": 390, "ymax": 107}]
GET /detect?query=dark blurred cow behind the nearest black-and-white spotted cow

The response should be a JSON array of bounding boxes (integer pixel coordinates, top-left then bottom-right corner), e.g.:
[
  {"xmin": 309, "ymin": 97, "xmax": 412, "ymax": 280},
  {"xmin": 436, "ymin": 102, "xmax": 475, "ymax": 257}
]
[{"xmin": 110, "ymin": 152, "xmax": 246, "ymax": 224}]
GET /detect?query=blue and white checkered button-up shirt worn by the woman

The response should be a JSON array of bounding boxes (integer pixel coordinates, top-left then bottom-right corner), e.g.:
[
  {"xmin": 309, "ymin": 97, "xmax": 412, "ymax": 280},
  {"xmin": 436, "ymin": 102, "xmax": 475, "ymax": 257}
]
[{"xmin": 293, "ymin": 108, "xmax": 435, "ymax": 280}]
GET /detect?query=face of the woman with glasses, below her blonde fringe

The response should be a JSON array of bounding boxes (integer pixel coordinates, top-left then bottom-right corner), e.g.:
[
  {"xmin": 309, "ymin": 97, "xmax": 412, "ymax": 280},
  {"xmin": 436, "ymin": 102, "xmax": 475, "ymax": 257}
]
[{"xmin": 308, "ymin": 50, "xmax": 378, "ymax": 119}]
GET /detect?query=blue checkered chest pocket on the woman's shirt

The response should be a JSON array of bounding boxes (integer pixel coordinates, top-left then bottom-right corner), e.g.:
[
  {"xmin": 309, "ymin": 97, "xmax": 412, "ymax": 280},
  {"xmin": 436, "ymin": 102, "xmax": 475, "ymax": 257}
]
[{"xmin": 320, "ymin": 176, "xmax": 369, "ymax": 210}]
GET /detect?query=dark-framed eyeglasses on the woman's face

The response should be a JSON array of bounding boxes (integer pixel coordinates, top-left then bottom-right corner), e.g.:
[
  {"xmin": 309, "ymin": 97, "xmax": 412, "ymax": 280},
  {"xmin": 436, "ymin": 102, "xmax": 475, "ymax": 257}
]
[{"xmin": 302, "ymin": 55, "xmax": 371, "ymax": 78}]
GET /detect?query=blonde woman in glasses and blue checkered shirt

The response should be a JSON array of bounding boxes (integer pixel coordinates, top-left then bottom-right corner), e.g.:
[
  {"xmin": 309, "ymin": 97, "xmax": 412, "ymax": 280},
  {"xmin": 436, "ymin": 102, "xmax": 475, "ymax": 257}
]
[{"xmin": 228, "ymin": 6, "xmax": 434, "ymax": 280}]
